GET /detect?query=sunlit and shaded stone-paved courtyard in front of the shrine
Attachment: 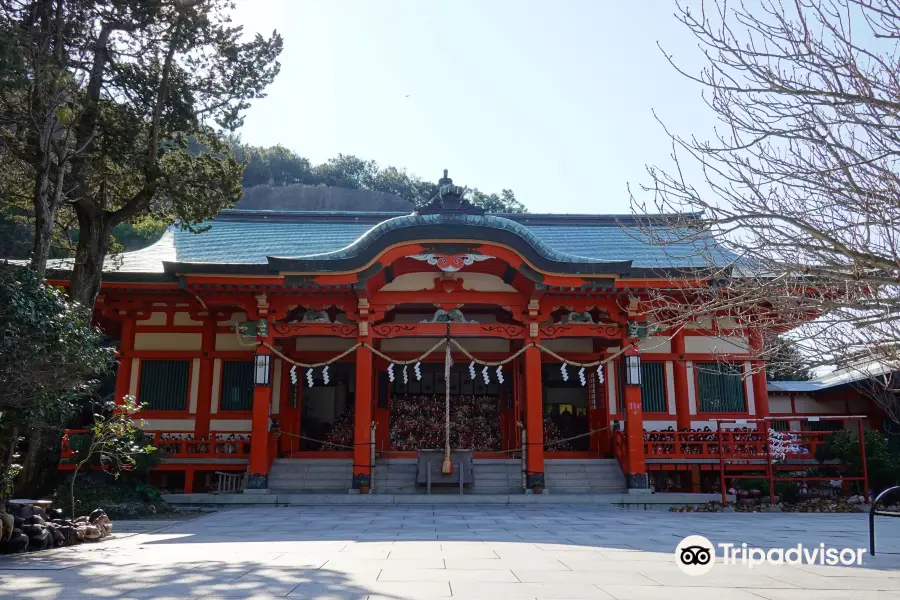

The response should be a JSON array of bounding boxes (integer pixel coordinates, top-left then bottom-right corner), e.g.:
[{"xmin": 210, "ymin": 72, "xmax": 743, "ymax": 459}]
[{"xmin": 0, "ymin": 506, "xmax": 900, "ymax": 600}]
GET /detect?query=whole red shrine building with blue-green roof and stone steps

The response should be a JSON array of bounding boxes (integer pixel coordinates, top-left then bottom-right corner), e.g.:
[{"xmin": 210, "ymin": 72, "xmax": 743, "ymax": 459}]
[{"xmin": 51, "ymin": 173, "xmax": 874, "ymax": 493}]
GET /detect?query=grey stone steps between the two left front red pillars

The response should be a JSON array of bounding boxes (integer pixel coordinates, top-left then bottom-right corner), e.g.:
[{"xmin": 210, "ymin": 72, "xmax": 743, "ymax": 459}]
[{"xmin": 269, "ymin": 458, "xmax": 353, "ymax": 494}]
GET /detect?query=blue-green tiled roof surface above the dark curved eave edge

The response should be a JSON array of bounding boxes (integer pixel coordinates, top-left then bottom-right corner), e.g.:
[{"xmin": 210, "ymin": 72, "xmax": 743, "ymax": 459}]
[{"xmin": 35, "ymin": 210, "xmax": 732, "ymax": 273}]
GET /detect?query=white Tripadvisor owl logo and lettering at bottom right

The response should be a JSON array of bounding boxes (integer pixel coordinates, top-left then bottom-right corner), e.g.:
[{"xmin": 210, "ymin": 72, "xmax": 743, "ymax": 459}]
[{"xmin": 675, "ymin": 535, "xmax": 866, "ymax": 575}]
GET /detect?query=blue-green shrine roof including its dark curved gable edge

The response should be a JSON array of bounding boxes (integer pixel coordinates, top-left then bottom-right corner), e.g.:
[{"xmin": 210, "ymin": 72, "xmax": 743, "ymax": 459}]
[{"xmin": 29, "ymin": 210, "xmax": 727, "ymax": 279}]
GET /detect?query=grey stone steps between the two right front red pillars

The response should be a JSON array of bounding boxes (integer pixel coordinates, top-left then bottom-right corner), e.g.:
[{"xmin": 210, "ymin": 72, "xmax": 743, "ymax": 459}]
[{"xmin": 544, "ymin": 458, "xmax": 627, "ymax": 494}]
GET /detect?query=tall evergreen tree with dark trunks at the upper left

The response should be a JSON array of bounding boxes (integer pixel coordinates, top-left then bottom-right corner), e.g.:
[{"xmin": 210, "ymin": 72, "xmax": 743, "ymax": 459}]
[{"xmin": 0, "ymin": 0, "xmax": 282, "ymax": 306}]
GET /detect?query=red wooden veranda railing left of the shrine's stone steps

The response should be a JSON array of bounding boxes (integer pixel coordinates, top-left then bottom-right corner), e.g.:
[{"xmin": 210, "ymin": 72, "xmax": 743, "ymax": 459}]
[{"xmin": 60, "ymin": 429, "xmax": 250, "ymax": 459}]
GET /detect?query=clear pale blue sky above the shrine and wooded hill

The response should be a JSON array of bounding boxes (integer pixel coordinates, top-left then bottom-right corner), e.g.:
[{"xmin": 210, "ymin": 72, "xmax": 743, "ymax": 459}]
[{"xmin": 235, "ymin": 0, "xmax": 713, "ymax": 213}]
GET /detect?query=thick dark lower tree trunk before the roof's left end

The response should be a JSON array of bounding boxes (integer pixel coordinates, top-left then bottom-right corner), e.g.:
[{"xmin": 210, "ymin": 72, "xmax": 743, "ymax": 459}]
[{"xmin": 69, "ymin": 204, "xmax": 114, "ymax": 310}]
